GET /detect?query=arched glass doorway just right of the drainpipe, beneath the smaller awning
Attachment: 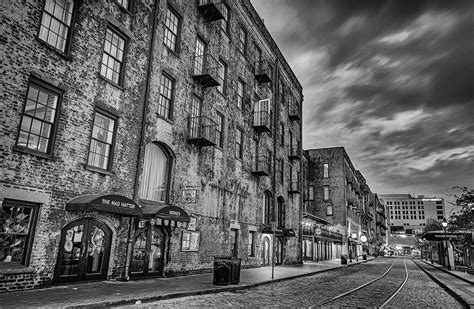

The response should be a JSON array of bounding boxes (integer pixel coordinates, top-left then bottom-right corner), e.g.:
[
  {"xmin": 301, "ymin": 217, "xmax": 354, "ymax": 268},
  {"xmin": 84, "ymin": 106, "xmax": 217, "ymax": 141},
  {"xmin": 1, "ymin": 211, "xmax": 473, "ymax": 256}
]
[{"xmin": 130, "ymin": 225, "xmax": 166, "ymax": 276}]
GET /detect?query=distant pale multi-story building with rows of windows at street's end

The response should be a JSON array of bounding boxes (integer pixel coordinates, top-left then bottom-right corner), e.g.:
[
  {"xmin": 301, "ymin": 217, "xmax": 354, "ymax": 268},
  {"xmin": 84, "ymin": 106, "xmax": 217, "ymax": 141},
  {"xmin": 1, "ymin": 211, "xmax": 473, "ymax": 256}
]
[{"xmin": 380, "ymin": 194, "xmax": 446, "ymax": 234}]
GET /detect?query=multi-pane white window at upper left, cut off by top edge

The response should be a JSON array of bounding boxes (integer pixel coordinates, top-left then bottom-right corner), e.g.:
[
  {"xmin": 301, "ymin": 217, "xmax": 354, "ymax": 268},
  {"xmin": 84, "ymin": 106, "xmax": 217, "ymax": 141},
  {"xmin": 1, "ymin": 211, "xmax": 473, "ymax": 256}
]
[{"xmin": 38, "ymin": 0, "xmax": 74, "ymax": 52}]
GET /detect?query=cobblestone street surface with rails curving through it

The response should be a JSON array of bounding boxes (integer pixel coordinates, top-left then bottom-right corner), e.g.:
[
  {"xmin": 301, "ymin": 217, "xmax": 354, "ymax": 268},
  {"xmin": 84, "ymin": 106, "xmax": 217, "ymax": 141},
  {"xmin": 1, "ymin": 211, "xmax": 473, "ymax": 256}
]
[{"xmin": 129, "ymin": 259, "xmax": 462, "ymax": 308}]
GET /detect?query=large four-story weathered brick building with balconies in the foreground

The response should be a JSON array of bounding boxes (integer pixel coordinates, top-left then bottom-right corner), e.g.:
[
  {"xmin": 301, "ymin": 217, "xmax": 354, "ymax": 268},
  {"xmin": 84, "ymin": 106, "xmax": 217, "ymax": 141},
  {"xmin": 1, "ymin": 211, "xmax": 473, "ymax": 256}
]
[{"xmin": 0, "ymin": 0, "xmax": 303, "ymax": 291}]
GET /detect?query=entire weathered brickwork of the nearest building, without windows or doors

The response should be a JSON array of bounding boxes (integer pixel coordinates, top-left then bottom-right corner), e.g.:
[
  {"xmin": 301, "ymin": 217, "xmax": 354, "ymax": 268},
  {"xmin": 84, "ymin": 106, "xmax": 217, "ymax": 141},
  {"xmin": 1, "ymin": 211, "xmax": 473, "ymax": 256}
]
[{"xmin": 0, "ymin": 0, "xmax": 302, "ymax": 287}]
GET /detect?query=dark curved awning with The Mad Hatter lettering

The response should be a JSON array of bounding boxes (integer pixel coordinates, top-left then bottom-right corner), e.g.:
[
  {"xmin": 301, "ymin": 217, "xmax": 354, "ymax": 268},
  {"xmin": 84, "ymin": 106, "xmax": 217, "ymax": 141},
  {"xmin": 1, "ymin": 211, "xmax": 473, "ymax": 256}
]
[{"xmin": 66, "ymin": 194, "xmax": 143, "ymax": 217}]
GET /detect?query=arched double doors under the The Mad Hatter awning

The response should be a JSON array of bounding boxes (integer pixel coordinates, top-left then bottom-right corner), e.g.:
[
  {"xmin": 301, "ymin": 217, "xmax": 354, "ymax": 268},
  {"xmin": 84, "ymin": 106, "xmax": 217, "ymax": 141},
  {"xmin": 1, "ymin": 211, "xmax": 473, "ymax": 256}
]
[{"xmin": 54, "ymin": 218, "xmax": 112, "ymax": 282}]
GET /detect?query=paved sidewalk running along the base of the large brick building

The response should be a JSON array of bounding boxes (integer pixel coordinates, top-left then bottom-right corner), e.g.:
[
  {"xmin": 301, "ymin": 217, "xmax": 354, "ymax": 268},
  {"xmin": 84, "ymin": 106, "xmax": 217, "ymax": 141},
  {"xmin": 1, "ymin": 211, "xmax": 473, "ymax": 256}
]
[{"xmin": 0, "ymin": 257, "xmax": 374, "ymax": 308}]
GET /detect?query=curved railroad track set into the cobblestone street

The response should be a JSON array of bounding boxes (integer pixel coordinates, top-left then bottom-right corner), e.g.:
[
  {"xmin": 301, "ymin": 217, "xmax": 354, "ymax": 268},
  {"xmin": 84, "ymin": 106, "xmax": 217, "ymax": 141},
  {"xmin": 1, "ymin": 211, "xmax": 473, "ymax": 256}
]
[{"xmin": 319, "ymin": 258, "xmax": 408, "ymax": 308}]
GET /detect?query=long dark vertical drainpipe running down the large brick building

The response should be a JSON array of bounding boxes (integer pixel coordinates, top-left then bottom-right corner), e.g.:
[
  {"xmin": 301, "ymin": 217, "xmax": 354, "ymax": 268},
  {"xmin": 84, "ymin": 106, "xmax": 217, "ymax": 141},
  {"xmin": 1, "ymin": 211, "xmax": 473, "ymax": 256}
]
[{"xmin": 123, "ymin": 0, "xmax": 159, "ymax": 280}]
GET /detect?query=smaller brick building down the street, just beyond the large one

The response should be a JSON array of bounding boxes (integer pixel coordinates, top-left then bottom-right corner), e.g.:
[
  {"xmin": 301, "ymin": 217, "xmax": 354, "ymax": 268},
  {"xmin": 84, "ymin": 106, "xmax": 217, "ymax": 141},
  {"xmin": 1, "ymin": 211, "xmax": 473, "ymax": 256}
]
[{"xmin": 304, "ymin": 147, "xmax": 375, "ymax": 258}]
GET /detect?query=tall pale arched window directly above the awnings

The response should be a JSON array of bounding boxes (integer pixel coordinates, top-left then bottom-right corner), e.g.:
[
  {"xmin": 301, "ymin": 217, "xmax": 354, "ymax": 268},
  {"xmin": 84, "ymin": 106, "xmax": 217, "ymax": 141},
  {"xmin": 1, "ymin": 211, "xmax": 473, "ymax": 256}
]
[{"xmin": 140, "ymin": 143, "xmax": 171, "ymax": 202}]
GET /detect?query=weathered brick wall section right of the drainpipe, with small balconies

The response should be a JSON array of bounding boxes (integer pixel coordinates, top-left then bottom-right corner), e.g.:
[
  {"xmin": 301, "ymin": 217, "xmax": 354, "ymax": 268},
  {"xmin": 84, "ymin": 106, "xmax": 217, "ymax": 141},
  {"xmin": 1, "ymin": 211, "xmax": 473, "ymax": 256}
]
[{"xmin": 141, "ymin": 1, "xmax": 300, "ymax": 271}]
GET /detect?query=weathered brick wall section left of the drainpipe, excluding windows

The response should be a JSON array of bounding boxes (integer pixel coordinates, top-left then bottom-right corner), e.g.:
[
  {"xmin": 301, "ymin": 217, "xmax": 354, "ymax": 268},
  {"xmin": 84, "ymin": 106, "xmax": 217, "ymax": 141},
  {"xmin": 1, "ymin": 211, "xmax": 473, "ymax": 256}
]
[{"xmin": 0, "ymin": 0, "xmax": 152, "ymax": 289}]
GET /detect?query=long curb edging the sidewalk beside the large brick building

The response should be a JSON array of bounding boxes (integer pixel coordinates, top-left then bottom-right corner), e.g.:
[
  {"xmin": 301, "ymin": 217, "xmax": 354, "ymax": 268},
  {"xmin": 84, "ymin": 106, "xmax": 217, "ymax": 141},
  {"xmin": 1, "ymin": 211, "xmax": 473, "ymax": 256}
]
[{"xmin": 69, "ymin": 259, "xmax": 373, "ymax": 308}]
